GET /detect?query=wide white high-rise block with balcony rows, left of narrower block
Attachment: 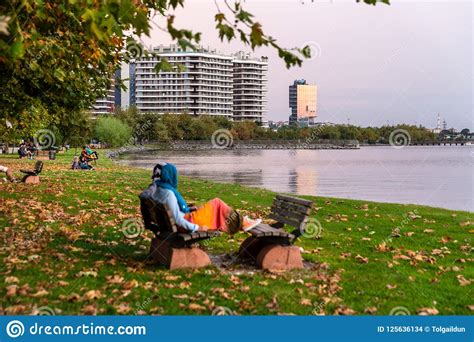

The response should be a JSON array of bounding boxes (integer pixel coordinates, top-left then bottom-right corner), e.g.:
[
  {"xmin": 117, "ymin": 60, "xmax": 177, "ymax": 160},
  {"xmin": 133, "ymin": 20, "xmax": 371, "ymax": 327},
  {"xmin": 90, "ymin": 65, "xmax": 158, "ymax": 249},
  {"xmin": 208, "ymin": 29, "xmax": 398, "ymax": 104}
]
[{"xmin": 134, "ymin": 45, "xmax": 233, "ymax": 118}]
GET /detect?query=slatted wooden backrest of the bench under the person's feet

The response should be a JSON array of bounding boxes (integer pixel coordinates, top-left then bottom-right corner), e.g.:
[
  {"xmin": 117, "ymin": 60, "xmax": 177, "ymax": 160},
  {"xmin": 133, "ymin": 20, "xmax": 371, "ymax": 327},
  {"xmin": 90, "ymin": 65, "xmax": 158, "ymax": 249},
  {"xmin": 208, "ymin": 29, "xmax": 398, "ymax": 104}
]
[{"xmin": 270, "ymin": 195, "xmax": 313, "ymax": 232}]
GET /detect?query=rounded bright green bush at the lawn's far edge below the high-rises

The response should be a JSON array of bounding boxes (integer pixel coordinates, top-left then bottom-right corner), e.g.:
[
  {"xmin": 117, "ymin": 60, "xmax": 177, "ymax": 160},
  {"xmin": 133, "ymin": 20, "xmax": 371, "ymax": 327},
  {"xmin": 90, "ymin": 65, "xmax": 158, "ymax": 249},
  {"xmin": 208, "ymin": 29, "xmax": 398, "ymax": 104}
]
[{"xmin": 94, "ymin": 117, "xmax": 132, "ymax": 147}]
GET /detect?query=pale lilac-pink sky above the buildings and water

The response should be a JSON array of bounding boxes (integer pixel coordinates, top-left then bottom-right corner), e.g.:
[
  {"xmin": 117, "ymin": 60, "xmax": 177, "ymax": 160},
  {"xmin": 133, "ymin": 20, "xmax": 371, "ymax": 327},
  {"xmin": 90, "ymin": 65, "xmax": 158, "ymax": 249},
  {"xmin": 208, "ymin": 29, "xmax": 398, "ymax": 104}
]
[{"xmin": 136, "ymin": 0, "xmax": 474, "ymax": 130}]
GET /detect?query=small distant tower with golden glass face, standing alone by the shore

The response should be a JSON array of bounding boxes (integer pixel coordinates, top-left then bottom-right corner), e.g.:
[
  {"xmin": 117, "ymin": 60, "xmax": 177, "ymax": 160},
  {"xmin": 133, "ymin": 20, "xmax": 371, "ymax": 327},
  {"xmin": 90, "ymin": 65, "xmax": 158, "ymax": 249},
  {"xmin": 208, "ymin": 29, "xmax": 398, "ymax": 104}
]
[{"xmin": 289, "ymin": 80, "xmax": 318, "ymax": 123}]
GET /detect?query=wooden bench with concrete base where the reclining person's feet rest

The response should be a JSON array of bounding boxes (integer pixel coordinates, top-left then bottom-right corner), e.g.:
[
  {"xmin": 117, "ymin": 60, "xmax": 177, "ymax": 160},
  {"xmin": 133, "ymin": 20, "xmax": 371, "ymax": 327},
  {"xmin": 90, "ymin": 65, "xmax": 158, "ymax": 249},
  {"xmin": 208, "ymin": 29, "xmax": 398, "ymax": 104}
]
[{"xmin": 239, "ymin": 195, "xmax": 313, "ymax": 269}]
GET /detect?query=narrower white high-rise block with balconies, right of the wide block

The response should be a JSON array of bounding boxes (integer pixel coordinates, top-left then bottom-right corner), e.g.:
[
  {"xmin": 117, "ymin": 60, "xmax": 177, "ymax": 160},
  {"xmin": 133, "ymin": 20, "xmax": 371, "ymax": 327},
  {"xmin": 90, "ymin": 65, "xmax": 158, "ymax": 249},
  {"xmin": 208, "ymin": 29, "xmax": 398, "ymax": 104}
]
[{"xmin": 233, "ymin": 52, "xmax": 268, "ymax": 125}]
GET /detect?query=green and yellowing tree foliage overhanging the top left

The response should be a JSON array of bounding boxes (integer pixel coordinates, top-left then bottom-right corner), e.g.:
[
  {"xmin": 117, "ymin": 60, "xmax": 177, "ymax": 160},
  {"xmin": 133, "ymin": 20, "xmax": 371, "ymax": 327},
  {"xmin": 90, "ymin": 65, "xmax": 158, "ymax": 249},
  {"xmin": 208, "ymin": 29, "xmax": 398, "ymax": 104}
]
[{"xmin": 0, "ymin": 0, "xmax": 388, "ymax": 140}]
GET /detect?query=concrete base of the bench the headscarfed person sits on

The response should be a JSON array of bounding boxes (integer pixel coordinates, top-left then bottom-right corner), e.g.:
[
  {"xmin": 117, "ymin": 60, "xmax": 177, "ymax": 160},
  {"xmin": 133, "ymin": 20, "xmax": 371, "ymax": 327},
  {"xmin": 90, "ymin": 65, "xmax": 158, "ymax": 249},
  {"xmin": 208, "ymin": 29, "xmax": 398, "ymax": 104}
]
[{"xmin": 148, "ymin": 238, "xmax": 211, "ymax": 270}]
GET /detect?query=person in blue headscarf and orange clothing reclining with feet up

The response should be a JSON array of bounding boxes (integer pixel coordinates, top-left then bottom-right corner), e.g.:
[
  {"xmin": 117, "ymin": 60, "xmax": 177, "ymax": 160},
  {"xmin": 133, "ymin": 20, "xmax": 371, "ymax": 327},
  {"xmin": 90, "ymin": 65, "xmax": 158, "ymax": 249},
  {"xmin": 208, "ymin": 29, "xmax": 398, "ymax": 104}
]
[{"xmin": 152, "ymin": 163, "xmax": 262, "ymax": 234}]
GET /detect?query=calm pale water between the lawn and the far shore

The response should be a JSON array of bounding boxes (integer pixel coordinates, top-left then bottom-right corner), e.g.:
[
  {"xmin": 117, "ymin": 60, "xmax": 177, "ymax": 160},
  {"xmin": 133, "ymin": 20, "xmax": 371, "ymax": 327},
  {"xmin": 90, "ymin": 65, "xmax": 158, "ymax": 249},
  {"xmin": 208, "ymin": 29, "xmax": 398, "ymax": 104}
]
[{"xmin": 123, "ymin": 146, "xmax": 474, "ymax": 211}]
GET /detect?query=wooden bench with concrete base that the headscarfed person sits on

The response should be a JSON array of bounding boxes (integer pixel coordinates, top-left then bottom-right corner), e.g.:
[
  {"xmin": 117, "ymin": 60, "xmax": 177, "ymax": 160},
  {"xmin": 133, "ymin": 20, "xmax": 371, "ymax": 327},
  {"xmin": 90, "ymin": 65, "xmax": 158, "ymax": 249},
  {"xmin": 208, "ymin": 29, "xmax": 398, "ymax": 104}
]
[{"xmin": 140, "ymin": 193, "xmax": 220, "ymax": 269}]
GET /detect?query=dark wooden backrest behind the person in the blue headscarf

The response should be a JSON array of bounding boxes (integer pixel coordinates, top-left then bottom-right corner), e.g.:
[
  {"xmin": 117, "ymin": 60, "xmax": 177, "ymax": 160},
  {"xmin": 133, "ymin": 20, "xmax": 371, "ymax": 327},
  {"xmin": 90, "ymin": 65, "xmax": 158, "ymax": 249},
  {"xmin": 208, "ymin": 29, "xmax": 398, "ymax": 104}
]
[{"xmin": 140, "ymin": 197, "xmax": 178, "ymax": 234}]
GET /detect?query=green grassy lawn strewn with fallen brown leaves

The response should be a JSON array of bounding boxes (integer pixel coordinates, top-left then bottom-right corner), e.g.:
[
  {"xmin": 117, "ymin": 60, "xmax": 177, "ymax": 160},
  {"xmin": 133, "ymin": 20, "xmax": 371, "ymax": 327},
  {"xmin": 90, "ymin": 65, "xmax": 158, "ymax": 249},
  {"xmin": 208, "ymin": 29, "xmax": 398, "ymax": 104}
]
[{"xmin": 0, "ymin": 153, "xmax": 474, "ymax": 315}]
